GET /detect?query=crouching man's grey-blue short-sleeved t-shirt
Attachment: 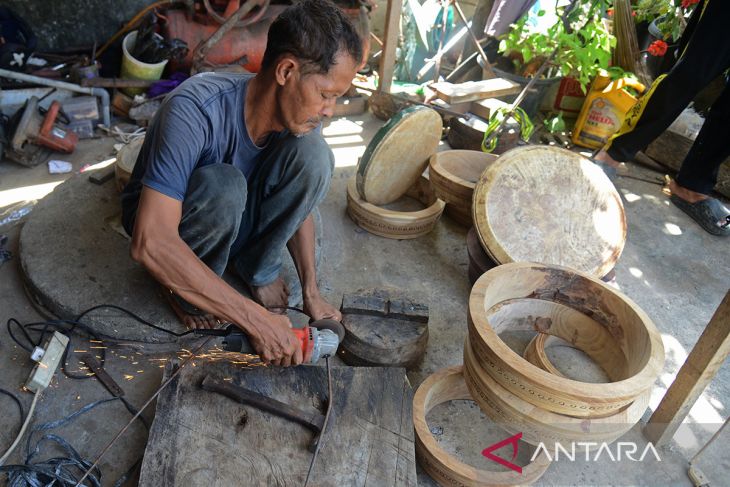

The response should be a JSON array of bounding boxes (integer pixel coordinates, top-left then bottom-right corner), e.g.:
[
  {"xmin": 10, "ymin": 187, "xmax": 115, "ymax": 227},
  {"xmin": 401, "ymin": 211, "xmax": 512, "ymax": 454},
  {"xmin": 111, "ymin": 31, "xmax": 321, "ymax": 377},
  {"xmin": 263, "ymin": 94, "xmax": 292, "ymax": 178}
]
[{"xmin": 122, "ymin": 73, "xmax": 286, "ymax": 219}]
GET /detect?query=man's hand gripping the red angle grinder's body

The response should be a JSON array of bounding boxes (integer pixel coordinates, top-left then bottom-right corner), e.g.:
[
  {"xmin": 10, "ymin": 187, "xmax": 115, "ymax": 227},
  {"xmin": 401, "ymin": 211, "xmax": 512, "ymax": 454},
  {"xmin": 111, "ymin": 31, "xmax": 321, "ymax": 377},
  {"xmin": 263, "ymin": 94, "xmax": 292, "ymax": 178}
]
[{"xmin": 249, "ymin": 313, "xmax": 304, "ymax": 367}]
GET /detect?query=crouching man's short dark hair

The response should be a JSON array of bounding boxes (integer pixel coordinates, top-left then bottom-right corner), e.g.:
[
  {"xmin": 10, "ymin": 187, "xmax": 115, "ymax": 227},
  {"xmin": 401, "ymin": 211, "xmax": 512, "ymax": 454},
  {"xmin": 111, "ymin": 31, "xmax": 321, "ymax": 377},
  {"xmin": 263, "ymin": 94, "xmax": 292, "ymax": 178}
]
[{"xmin": 261, "ymin": 0, "xmax": 363, "ymax": 74}]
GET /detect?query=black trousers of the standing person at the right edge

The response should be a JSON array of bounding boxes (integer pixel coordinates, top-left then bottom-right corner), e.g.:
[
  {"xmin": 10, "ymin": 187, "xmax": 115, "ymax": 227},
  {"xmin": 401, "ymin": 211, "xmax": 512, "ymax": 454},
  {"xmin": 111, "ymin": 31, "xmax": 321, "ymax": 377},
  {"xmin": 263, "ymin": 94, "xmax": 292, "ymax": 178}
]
[{"xmin": 607, "ymin": 0, "xmax": 730, "ymax": 194}]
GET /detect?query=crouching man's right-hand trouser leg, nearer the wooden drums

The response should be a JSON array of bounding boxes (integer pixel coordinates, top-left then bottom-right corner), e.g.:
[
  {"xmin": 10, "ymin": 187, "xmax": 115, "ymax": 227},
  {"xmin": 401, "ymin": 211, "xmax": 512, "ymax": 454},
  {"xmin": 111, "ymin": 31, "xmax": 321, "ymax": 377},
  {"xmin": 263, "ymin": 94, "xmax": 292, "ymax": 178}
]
[{"xmin": 231, "ymin": 132, "xmax": 334, "ymax": 296}]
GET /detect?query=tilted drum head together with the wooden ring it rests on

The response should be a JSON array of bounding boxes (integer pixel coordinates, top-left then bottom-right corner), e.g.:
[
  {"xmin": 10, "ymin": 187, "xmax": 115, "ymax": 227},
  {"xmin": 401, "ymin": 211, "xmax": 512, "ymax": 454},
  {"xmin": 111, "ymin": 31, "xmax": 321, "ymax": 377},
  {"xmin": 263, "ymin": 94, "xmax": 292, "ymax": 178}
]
[{"xmin": 347, "ymin": 106, "xmax": 445, "ymax": 239}]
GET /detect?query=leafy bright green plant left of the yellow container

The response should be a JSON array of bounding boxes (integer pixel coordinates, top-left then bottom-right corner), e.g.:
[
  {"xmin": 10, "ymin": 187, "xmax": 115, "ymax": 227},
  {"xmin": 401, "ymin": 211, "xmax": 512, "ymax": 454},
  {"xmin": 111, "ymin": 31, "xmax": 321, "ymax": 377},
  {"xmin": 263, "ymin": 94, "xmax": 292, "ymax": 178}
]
[{"xmin": 499, "ymin": 0, "xmax": 616, "ymax": 92}]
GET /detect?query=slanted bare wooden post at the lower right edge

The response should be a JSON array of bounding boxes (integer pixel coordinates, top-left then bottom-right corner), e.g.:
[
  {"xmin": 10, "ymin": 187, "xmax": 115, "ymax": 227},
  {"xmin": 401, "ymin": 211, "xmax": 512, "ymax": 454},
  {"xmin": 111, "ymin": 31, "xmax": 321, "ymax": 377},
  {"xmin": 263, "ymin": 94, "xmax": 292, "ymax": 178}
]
[{"xmin": 644, "ymin": 290, "xmax": 730, "ymax": 446}]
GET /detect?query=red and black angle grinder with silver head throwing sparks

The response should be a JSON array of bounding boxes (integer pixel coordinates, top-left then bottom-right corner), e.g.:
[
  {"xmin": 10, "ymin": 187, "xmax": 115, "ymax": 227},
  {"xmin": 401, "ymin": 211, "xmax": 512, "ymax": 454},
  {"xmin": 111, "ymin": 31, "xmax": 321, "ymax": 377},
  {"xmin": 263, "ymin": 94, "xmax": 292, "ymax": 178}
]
[{"xmin": 196, "ymin": 319, "xmax": 345, "ymax": 364}]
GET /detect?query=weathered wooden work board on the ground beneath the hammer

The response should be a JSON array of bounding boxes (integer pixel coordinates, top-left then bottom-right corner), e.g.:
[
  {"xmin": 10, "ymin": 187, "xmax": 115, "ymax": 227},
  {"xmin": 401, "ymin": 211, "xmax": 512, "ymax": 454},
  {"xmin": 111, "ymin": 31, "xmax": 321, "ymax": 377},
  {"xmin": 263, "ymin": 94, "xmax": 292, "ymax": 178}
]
[{"xmin": 139, "ymin": 362, "xmax": 416, "ymax": 487}]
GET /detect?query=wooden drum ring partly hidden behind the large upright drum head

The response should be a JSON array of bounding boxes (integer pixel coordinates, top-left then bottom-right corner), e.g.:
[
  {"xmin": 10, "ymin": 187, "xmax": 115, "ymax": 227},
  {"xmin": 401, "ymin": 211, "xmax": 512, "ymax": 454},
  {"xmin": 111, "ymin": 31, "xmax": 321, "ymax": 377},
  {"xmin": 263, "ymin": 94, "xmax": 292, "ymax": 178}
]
[{"xmin": 428, "ymin": 150, "xmax": 497, "ymax": 227}]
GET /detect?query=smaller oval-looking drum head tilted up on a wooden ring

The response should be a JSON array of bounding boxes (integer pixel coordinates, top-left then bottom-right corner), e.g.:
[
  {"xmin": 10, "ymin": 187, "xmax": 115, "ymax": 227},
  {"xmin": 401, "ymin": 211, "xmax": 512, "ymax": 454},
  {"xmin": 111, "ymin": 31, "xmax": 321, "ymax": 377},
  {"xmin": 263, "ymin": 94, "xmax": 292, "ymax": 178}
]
[{"xmin": 357, "ymin": 106, "xmax": 443, "ymax": 206}]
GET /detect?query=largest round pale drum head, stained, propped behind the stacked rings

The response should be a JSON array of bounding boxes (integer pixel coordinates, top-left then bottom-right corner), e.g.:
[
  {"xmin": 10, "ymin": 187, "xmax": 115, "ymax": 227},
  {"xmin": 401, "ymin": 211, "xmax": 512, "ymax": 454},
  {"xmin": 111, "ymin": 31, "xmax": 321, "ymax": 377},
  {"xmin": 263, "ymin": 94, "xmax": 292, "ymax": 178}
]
[{"xmin": 472, "ymin": 146, "xmax": 626, "ymax": 277}]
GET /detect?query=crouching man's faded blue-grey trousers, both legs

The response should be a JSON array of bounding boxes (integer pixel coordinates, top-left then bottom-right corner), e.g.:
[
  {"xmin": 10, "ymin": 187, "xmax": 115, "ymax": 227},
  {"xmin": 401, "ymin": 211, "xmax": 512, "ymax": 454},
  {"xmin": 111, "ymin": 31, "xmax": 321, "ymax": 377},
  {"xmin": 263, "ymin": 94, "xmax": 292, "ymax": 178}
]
[{"xmin": 134, "ymin": 132, "xmax": 334, "ymax": 286}]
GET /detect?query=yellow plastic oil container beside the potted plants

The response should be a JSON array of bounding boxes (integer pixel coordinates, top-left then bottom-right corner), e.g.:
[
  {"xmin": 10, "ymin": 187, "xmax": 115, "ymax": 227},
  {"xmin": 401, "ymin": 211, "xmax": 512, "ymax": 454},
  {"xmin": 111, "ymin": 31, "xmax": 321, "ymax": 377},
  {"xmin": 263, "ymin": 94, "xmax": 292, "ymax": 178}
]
[{"xmin": 573, "ymin": 71, "xmax": 646, "ymax": 149}]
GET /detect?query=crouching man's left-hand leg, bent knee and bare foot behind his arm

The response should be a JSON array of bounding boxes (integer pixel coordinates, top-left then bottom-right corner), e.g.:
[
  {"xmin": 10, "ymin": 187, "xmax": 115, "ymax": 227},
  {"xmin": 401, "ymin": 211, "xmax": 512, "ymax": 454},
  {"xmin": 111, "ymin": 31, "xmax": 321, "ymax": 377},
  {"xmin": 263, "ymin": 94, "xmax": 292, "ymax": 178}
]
[{"xmin": 166, "ymin": 164, "xmax": 247, "ymax": 328}]
